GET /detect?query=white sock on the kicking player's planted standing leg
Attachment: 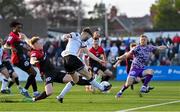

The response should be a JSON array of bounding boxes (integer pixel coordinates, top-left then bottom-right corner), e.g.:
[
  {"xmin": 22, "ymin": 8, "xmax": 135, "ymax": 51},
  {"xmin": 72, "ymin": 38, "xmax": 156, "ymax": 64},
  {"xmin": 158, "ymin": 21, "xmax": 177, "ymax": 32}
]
[{"xmin": 58, "ymin": 81, "xmax": 74, "ymax": 98}]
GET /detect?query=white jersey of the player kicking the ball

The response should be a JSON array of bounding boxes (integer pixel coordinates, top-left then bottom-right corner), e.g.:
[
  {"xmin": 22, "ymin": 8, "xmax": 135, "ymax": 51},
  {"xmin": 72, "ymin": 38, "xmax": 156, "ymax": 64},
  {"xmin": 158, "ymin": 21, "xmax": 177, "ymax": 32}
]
[{"xmin": 61, "ymin": 32, "xmax": 86, "ymax": 57}]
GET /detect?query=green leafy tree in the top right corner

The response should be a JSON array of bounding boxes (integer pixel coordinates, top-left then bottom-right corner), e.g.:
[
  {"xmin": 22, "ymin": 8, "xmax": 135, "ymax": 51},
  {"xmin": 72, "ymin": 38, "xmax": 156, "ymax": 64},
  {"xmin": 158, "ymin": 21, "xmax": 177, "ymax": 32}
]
[{"xmin": 151, "ymin": 0, "xmax": 180, "ymax": 30}]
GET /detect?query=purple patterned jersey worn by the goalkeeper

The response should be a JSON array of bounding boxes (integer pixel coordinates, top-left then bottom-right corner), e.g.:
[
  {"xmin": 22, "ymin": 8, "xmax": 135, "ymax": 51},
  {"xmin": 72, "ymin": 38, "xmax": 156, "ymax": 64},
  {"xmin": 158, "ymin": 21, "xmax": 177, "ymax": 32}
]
[{"xmin": 131, "ymin": 45, "xmax": 156, "ymax": 68}]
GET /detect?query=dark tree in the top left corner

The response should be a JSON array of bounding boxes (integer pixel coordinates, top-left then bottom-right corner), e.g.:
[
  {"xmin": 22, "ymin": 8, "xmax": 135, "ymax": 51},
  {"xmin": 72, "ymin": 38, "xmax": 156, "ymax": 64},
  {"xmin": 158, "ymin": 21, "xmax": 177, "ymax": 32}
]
[{"xmin": 0, "ymin": 0, "xmax": 30, "ymax": 19}]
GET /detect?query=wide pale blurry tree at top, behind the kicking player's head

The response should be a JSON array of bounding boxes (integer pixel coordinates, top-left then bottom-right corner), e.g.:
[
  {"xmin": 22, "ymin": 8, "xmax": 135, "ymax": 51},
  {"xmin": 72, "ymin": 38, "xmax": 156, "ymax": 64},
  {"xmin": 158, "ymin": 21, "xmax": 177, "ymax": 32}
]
[{"xmin": 30, "ymin": 0, "xmax": 83, "ymax": 27}]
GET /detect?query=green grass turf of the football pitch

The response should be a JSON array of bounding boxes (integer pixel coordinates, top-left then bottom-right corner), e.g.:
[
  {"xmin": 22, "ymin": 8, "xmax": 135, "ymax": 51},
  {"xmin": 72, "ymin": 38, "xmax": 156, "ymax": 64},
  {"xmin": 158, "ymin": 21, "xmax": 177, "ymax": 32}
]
[{"xmin": 0, "ymin": 81, "xmax": 180, "ymax": 112}]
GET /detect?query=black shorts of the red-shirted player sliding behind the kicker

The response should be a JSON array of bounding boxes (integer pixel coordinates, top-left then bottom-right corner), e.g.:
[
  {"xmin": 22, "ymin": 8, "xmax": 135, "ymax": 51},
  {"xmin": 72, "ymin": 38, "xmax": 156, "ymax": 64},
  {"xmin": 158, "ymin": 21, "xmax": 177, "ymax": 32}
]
[{"xmin": 45, "ymin": 71, "xmax": 66, "ymax": 85}]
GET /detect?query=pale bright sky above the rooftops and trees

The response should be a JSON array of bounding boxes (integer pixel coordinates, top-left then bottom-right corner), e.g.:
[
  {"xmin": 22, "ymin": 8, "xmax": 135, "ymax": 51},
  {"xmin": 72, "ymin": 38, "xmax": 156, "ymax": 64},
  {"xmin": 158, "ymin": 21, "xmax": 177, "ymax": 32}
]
[{"xmin": 82, "ymin": 0, "xmax": 156, "ymax": 17}]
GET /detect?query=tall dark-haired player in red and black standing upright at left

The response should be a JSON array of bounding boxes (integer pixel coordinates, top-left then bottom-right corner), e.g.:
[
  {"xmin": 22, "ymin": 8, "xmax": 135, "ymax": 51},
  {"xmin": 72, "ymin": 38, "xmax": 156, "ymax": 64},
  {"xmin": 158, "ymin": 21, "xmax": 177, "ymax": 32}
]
[{"xmin": 5, "ymin": 21, "xmax": 39, "ymax": 97}]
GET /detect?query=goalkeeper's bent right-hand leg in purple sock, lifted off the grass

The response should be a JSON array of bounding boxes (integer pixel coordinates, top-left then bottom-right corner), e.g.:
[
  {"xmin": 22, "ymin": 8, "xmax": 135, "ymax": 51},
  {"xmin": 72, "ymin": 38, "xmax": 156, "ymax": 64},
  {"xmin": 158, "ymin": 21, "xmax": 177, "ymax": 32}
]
[{"xmin": 141, "ymin": 69, "xmax": 154, "ymax": 93}]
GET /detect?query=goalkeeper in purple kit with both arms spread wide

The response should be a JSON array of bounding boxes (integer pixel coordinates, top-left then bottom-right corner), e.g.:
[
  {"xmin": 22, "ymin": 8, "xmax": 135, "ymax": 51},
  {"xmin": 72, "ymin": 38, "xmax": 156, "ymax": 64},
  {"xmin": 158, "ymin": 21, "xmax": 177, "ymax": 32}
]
[{"xmin": 116, "ymin": 35, "xmax": 167, "ymax": 98}]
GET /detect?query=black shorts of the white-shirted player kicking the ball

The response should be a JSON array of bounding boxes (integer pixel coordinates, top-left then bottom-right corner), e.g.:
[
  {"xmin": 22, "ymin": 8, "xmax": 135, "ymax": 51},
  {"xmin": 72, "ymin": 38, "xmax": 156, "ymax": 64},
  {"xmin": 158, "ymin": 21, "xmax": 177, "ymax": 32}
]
[{"xmin": 63, "ymin": 55, "xmax": 84, "ymax": 74}]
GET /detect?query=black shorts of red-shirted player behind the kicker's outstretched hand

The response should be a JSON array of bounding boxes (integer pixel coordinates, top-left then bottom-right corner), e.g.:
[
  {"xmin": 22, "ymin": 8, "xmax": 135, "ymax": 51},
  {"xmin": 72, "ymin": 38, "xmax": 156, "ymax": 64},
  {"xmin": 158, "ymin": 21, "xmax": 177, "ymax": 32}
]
[{"xmin": 90, "ymin": 63, "xmax": 107, "ymax": 73}]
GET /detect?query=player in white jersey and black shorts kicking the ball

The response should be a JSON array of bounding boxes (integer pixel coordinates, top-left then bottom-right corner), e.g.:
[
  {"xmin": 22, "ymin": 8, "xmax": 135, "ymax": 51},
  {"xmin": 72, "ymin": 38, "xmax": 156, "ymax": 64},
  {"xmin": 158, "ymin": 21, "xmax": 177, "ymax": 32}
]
[{"xmin": 57, "ymin": 28, "xmax": 111, "ymax": 101}]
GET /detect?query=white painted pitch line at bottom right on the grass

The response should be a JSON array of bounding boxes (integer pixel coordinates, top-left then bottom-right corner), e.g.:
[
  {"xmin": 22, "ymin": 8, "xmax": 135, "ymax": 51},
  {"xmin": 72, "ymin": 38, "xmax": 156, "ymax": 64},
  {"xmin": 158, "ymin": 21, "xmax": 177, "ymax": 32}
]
[{"xmin": 116, "ymin": 100, "xmax": 180, "ymax": 112}]
